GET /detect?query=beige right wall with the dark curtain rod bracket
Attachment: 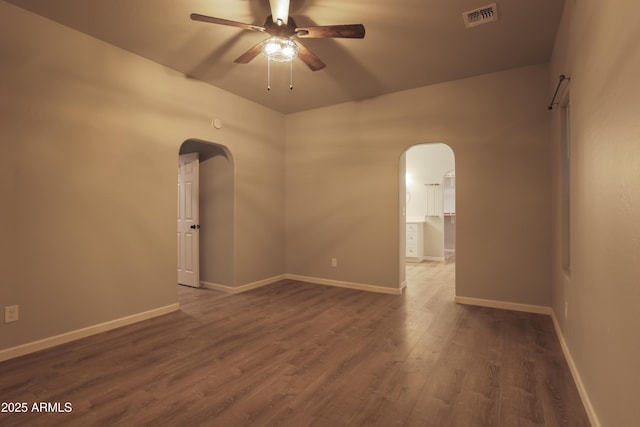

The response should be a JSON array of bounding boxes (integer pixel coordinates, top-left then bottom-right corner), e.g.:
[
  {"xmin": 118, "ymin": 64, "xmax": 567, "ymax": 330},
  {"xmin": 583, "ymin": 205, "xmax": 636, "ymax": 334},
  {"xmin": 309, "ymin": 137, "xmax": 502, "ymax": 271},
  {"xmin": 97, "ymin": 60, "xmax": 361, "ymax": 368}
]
[{"xmin": 548, "ymin": 0, "xmax": 640, "ymax": 426}]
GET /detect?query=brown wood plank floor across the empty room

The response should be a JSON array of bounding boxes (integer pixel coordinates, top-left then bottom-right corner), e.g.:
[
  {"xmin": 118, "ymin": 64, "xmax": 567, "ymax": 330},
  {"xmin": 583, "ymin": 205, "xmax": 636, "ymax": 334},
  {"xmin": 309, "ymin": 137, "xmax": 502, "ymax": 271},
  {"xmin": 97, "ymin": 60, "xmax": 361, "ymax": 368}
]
[{"xmin": 0, "ymin": 262, "xmax": 589, "ymax": 427}]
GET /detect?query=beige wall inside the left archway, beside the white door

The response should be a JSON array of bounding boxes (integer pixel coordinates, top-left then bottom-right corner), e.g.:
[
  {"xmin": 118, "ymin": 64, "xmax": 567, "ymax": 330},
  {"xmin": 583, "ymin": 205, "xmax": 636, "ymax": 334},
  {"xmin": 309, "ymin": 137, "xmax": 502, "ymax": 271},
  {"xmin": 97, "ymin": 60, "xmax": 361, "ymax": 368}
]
[{"xmin": 179, "ymin": 139, "xmax": 235, "ymax": 286}]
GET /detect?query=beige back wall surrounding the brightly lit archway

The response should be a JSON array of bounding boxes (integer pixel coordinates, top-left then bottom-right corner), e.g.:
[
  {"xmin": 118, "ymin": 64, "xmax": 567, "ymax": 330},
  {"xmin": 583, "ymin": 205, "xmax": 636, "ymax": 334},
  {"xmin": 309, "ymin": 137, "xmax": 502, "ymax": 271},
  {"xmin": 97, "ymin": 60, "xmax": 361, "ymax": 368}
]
[{"xmin": 286, "ymin": 66, "xmax": 550, "ymax": 305}]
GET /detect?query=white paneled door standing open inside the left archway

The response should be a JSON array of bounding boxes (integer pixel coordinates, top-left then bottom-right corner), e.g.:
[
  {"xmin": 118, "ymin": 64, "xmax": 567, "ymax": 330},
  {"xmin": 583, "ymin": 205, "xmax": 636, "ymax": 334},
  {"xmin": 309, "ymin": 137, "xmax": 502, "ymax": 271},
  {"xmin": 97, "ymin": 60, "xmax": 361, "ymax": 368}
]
[{"xmin": 178, "ymin": 153, "xmax": 200, "ymax": 288}]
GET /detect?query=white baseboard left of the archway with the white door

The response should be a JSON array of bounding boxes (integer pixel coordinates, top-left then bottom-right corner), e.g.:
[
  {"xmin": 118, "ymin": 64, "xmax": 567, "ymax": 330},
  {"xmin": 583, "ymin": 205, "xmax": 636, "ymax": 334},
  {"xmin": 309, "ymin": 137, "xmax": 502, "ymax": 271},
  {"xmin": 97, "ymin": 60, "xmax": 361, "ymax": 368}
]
[{"xmin": 0, "ymin": 303, "xmax": 180, "ymax": 362}]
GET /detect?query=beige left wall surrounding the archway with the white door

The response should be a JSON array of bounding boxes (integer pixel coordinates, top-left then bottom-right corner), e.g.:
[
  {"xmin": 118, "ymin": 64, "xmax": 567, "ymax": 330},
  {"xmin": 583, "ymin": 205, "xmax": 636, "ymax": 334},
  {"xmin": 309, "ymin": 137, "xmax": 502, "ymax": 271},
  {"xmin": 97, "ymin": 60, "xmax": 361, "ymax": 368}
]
[{"xmin": 0, "ymin": 2, "xmax": 284, "ymax": 348}]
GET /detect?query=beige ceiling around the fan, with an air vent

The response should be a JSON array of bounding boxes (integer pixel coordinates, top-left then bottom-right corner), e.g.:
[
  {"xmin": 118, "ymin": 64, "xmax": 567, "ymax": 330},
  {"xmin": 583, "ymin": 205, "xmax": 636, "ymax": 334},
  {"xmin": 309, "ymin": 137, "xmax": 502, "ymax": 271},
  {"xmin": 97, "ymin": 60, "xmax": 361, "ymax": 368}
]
[{"xmin": 6, "ymin": 0, "xmax": 564, "ymax": 113}]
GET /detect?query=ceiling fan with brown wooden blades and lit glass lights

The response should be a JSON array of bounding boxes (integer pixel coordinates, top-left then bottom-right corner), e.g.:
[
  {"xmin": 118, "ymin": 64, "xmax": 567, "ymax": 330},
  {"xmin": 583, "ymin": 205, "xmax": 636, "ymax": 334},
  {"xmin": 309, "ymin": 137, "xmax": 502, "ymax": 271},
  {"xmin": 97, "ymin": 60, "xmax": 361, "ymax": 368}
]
[{"xmin": 191, "ymin": 0, "xmax": 365, "ymax": 71}]
